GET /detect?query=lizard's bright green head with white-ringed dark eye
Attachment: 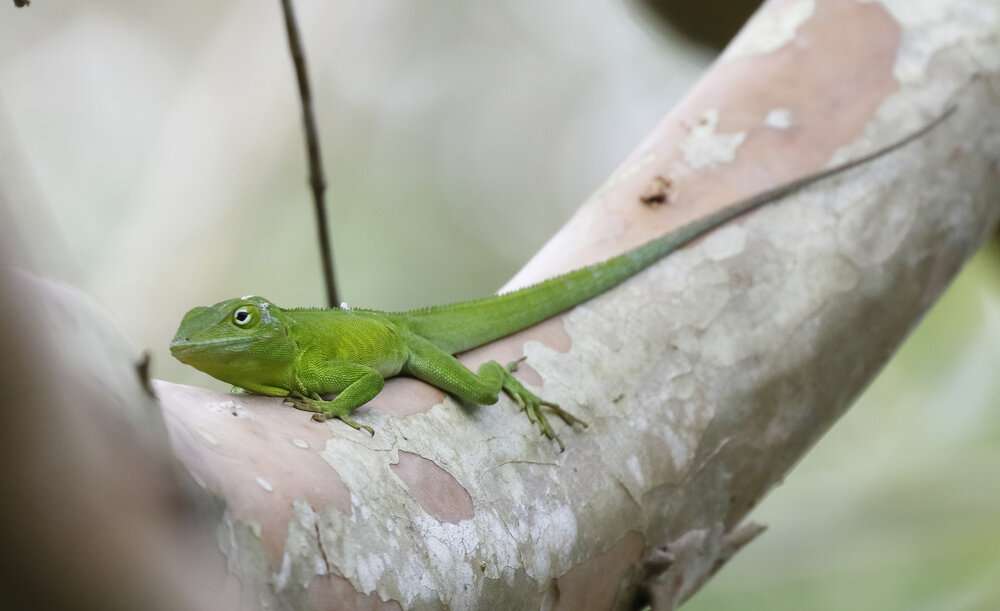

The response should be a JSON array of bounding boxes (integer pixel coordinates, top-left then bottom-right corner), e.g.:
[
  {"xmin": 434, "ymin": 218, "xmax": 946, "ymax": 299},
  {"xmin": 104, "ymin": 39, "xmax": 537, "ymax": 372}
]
[{"xmin": 170, "ymin": 296, "xmax": 294, "ymax": 387}]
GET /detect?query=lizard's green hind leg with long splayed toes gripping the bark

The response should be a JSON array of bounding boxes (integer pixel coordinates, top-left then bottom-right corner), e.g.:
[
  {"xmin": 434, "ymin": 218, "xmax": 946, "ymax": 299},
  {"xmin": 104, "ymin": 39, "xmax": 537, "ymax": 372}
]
[{"xmin": 405, "ymin": 337, "xmax": 587, "ymax": 450}]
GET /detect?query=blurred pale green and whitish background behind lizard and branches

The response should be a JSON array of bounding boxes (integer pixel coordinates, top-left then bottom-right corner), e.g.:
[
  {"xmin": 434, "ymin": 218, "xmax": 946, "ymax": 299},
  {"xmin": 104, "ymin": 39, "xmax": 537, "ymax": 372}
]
[{"xmin": 0, "ymin": 0, "xmax": 1000, "ymax": 610}]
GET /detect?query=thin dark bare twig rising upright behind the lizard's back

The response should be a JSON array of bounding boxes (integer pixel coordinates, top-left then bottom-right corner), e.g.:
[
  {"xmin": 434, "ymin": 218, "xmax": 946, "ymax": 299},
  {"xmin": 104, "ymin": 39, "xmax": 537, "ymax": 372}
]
[{"xmin": 281, "ymin": 0, "xmax": 340, "ymax": 308}]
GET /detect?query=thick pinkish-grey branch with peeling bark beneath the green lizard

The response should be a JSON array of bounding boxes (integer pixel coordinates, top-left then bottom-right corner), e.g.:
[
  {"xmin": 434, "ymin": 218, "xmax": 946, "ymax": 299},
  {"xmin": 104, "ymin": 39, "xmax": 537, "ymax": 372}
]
[{"xmin": 3, "ymin": 0, "xmax": 1000, "ymax": 610}]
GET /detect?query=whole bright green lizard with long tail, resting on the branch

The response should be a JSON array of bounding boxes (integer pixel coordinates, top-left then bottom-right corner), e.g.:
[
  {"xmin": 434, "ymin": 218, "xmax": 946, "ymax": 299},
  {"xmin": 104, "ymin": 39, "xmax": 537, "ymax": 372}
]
[{"xmin": 170, "ymin": 108, "xmax": 954, "ymax": 449}]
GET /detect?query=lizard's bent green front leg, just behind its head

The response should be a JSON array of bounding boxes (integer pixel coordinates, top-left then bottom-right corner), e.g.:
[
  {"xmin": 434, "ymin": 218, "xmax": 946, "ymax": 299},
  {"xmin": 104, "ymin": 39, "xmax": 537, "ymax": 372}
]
[{"xmin": 288, "ymin": 363, "xmax": 385, "ymax": 435}]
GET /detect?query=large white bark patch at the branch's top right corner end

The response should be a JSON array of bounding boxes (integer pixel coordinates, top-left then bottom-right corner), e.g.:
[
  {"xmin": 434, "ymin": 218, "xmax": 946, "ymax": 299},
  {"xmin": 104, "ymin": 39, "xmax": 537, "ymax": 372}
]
[{"xmin": 860, "ymin": 0, "xmax": 1000, "ymax": 84}]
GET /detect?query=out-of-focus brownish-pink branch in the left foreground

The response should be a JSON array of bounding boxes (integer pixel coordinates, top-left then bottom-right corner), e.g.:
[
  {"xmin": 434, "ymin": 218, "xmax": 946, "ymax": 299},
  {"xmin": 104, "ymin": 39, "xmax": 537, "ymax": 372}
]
[{"xmin": 0, "ymin": 222, "xmax": 237, "ymax": 611}]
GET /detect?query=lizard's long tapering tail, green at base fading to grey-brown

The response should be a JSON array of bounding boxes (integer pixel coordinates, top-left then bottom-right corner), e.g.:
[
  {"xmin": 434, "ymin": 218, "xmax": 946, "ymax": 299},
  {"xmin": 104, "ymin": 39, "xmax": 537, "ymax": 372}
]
[{"xmin": 391, "ymin": 106, "xmax": 955, "ymax": 354}]
